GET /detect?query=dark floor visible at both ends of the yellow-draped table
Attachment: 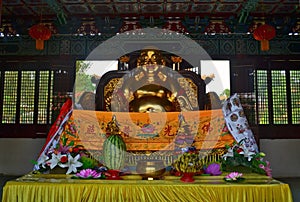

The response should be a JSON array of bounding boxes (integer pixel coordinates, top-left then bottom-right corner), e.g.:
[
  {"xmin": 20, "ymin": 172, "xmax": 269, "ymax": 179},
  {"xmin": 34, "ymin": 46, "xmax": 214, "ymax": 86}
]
[{"xmin": 0, "ymin": 174, "xmax": 300, "ymax": 202}]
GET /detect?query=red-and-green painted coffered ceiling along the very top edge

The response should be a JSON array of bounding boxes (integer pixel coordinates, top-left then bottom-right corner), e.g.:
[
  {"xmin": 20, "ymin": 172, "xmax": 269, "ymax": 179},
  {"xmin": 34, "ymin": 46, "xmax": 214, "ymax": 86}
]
[{"xmin": 2, "ymin": 0, "xmax": 300, "ymax": 19}]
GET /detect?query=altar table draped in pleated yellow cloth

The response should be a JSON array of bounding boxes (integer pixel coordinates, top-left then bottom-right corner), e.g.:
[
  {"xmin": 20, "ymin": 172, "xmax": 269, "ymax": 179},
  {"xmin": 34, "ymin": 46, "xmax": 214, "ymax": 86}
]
[{"xmin": 2, "ymin": 175, "xmax": 292, "ymax": 202}]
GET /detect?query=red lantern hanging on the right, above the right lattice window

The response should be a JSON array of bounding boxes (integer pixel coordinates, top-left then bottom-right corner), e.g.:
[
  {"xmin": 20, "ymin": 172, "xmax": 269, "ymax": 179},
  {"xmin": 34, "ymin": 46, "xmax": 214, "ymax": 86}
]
[{"xmin": 253, "ymin": 24, "xmax": 276, "ymax": 51}]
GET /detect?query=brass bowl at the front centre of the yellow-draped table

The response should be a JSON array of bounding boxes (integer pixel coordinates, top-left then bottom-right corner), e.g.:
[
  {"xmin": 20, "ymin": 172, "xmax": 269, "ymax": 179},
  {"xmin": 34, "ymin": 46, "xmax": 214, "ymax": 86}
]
[{"xmin": 136, "ymin": 160, "xmax": 166, "ymax": 178}]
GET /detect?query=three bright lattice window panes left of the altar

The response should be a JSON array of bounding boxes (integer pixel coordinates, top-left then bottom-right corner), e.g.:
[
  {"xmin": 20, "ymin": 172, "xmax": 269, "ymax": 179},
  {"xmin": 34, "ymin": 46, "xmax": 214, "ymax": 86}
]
[{"xmin": 1, "ymin": 70, "xmax": 53, "ymax": 124}]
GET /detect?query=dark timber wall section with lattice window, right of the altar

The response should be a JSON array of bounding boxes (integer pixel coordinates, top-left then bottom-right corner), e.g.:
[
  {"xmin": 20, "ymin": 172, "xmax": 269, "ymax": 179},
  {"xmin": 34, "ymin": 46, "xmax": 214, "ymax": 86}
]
[{"xmin": 231, "ymin": 58, "xmax": 300, "ymax": 139}]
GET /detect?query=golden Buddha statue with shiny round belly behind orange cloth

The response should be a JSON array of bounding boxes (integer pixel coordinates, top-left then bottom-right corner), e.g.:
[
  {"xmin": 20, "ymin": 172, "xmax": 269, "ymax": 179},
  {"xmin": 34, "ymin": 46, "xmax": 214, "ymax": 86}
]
[{"xmin": 129, "ymin": 49, "xmax": 179, "ymax": 113}]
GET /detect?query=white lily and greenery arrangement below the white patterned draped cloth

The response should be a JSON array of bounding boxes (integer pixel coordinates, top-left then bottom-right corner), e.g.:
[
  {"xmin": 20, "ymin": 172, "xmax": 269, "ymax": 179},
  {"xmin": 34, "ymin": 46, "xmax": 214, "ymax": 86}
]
[{"xmin": 221, "ymin": 144, "xmax": 272, "ymax": 177}]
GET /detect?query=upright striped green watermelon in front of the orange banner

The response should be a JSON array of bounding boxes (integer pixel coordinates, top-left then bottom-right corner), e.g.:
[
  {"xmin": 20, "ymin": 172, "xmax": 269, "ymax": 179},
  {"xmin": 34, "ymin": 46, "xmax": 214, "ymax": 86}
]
[{"xmin": 103, "ymin": 134, "xmax": 126, "ymax": 170}]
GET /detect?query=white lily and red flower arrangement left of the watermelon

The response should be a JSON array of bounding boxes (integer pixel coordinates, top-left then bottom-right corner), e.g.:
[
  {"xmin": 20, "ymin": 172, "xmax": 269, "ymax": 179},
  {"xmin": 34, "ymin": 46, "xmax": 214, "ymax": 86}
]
[{"xmin": 33, "ymin": 137, "xmax": 98, "ymax": 174}]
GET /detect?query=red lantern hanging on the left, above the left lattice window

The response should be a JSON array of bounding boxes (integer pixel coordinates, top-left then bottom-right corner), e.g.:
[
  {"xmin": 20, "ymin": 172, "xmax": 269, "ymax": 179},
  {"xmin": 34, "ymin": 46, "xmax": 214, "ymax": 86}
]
[{"xmin": 29, "ymin": 24, "xmax": 51, "ymax": 50}]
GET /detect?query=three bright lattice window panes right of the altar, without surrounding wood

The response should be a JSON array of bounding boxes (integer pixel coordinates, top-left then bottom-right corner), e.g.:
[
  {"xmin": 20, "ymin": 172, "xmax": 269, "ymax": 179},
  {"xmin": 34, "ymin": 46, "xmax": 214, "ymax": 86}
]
[{"xmin": 256, "ymin": 69, "xmax": 300, "ymax": 125}]
